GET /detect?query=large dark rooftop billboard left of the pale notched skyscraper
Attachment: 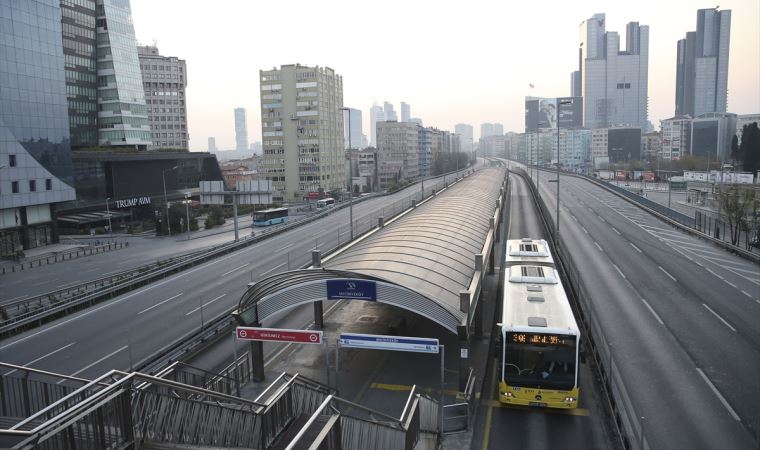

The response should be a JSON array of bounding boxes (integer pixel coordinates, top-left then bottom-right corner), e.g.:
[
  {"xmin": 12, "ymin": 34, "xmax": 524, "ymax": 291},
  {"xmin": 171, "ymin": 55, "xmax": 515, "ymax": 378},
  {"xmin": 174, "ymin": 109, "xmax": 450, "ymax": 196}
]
[{"xmin": 525, "ymin": 97, "xmax": 583, "ymax": 131}]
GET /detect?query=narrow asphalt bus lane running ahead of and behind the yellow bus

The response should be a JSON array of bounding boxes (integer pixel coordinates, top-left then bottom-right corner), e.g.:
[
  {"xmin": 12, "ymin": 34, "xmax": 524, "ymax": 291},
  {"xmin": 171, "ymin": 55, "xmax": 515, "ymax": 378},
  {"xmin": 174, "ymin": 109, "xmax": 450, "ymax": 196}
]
[{"xmin": 471, "ymin": 170, "xmax": 617, "ymax": 450}]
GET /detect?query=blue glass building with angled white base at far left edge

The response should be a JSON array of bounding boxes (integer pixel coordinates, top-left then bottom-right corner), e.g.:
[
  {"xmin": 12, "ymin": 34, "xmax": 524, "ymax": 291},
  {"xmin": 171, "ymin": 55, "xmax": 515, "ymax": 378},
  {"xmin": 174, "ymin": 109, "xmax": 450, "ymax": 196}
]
[{"xmin": 0, "ymin": 0, "xmax": 78, "ymax": 256}]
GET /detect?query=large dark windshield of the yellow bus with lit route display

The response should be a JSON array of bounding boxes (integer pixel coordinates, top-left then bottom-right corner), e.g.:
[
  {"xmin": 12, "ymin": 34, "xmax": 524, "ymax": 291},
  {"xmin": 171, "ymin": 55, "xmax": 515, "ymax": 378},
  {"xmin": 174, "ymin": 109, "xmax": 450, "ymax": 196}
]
[{"xmin": 504, "ymin": 332, "xmax": 577, "ymax": 390}]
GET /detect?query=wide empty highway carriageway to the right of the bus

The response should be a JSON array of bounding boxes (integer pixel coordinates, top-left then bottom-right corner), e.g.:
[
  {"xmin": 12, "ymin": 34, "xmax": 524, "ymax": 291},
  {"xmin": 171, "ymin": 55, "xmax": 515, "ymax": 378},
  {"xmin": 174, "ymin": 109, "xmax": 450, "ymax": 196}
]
[{"xmin": 528, "ymin": 165, "xmax": 760, "ymax": 449}]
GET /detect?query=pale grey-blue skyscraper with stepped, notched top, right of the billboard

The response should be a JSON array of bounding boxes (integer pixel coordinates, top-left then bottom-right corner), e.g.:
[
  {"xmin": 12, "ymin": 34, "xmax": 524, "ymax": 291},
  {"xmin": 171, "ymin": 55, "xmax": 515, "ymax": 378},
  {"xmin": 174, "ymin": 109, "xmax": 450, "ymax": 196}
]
[{"xmin": 580, "ymin": 14, "xmax": 649, "ymax": 128}]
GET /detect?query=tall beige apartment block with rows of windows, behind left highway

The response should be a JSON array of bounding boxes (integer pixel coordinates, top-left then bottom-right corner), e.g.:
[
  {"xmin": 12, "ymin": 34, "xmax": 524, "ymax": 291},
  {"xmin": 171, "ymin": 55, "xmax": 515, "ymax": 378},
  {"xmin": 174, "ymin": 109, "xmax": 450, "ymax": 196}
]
[{"xmin": 259, "ymin": 64, "xmax": 347, "ymax": 202}]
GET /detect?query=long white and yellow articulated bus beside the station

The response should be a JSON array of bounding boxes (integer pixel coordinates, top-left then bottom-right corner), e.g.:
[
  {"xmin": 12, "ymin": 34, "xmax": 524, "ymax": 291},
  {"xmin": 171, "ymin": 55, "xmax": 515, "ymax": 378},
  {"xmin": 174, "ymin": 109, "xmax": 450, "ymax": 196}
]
[{"xmin": 499, "ymin": 239, "xmax": 581, "ymax": 409}]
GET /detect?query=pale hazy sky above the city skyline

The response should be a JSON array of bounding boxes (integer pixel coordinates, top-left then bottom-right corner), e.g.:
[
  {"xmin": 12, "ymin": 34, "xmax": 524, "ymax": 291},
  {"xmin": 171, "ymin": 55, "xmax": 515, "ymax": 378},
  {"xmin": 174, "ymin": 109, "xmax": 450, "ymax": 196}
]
[{"xmin": 132, "ymin": 0, "xmax": 760, "ymax": 151}]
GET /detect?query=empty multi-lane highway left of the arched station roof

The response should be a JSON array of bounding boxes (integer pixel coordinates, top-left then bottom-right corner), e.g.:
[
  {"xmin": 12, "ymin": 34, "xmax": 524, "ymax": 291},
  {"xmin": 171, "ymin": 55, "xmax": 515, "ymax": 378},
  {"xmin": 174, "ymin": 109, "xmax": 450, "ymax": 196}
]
[{"xmin": 0, "ymin": 171, "xmax": 470, "ymax": 378}]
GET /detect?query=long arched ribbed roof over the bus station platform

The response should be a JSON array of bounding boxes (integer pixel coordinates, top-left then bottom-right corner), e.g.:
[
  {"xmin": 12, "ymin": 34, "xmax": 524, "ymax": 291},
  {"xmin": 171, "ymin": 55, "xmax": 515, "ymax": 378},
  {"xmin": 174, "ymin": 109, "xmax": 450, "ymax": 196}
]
[{"xmin": 323, "ymin": 168, "xmax": 504, "ymax": 319}]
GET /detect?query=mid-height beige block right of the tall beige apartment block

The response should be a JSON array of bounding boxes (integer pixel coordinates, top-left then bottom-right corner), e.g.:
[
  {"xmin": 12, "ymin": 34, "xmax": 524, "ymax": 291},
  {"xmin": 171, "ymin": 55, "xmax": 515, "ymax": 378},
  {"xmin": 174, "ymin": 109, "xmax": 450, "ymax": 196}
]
[{"xmin": 377, "ymin": 122, "xmax": 418, "ymax": 189}]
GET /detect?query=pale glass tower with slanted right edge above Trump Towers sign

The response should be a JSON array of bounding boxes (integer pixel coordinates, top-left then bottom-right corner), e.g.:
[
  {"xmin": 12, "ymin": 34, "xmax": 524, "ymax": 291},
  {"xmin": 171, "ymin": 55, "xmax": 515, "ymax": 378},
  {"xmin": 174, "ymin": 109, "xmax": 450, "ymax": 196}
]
[{"xmin": 95, "ymin": 0, "xmax": 151, "ymax": 150}]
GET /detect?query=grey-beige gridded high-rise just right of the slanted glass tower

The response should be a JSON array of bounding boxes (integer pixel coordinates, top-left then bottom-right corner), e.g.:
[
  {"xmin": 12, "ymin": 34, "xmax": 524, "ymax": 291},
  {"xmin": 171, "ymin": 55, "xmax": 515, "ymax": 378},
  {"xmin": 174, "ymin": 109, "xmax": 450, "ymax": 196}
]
[{"xmin": 137, "ymin": 46, "xmax": 190, "ymax": 150}]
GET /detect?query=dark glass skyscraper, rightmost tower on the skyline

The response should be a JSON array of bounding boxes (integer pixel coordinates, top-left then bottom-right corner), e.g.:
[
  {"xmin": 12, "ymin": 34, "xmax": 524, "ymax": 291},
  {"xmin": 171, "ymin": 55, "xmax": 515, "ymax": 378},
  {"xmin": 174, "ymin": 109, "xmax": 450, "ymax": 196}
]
[{"xmin": 676, "ymin": 8, "xmax": 731, "ymax": 117}]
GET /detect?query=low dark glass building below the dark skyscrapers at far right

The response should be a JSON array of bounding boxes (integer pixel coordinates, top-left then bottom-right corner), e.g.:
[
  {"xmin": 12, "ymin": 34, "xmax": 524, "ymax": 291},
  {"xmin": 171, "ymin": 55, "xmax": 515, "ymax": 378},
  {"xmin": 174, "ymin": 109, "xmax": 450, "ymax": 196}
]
[{"xmin": 691, "ymin": 112, "xmax": 737, "ymax": 161}]
